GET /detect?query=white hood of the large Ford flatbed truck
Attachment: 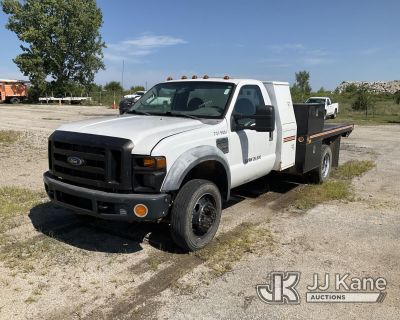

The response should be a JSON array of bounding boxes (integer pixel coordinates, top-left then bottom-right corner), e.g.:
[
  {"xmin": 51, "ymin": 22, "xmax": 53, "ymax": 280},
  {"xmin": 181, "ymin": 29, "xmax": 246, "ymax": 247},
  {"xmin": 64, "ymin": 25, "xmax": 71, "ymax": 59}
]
[{"xmin": 57, "ymin": 115, "xmax": 206, "ymax": 154}]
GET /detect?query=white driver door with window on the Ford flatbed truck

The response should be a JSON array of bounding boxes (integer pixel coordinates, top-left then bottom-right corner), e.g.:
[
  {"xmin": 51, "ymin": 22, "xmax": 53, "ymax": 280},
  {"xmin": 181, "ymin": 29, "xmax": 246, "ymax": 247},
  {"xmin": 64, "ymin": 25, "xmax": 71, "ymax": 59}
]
[{"xmin": 227, "ymin": 85, "xmax": 275, "ymax": 187}]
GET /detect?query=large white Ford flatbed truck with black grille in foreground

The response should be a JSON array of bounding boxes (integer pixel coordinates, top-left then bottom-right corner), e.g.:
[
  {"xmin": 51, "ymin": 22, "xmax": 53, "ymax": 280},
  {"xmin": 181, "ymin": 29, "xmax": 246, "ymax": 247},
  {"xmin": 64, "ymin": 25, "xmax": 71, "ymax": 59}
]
[{"xmin": 44, "ymin": 77, "xmax": 353, "ymax": 250}]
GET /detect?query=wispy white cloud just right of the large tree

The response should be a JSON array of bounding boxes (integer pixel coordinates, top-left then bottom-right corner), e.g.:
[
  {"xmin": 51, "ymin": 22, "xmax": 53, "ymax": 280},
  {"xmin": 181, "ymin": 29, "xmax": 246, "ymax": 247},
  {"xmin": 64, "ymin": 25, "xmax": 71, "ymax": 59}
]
[{"xmin": 104, "ymin": 34, "xmax": 187, "ymax": 63}]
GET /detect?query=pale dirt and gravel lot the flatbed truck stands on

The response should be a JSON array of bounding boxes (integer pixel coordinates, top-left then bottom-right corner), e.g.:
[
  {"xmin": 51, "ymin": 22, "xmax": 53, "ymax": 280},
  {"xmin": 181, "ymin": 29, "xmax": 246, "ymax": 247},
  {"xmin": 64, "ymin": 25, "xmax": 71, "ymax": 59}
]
[{"xmin": 0, "ymin": 105, "xmax": 400, "ymax": 319}]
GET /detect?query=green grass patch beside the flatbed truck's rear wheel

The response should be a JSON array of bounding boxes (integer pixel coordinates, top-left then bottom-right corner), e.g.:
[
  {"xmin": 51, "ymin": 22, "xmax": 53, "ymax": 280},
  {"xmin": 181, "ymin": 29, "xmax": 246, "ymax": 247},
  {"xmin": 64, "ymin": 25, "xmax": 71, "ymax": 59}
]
[{"xmin": 293, "ymin": 160, "xmax": 375, "ymax": 210}]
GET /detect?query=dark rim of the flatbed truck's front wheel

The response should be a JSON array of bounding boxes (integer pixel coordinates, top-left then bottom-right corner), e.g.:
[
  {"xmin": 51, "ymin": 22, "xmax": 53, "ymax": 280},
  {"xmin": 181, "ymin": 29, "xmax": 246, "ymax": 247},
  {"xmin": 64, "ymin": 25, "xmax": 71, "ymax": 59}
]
[{"xmin": 192, "ymin": 194, "xmax": 217, "ymax": 237}]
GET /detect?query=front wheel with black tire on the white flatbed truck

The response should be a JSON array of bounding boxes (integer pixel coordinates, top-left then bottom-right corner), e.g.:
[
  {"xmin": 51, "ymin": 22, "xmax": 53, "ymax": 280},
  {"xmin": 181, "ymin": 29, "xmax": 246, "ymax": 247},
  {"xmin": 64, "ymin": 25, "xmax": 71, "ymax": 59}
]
[{"xmin": 171, "ymin": 179, "xmax": 222, "ymax": 251}]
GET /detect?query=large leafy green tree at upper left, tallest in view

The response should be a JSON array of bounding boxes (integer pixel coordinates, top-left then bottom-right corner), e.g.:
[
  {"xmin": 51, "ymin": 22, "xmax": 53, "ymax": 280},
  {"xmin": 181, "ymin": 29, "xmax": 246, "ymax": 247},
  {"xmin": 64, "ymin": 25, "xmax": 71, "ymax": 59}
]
[{"xmin": 1, "ymin": 0, "xmax": 105, "ymax": 94}]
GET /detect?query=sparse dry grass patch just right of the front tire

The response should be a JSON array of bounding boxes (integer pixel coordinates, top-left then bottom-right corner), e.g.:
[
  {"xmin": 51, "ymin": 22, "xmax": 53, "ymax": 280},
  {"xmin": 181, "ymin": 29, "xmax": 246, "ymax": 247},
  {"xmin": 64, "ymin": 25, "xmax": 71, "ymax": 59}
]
[{"xmin": 194, "ymin": 223, "xmax": 273, "ymax": 276}]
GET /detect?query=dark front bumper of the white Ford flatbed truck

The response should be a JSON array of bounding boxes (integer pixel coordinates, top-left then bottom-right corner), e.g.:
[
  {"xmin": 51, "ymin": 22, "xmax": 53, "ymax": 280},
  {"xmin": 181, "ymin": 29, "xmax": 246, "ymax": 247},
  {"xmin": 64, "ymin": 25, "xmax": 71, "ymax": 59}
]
[{"xmin": 43, "ymin": 172, "xmax": 171, "ymax": 221}]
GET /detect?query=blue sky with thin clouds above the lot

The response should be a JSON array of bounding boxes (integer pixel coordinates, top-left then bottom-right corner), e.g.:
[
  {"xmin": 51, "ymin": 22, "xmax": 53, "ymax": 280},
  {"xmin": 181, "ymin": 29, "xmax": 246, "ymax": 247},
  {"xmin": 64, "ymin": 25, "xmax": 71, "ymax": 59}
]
[{"xmin": 0, "ymin": 0, "xmax": 400, "ymax": 89}]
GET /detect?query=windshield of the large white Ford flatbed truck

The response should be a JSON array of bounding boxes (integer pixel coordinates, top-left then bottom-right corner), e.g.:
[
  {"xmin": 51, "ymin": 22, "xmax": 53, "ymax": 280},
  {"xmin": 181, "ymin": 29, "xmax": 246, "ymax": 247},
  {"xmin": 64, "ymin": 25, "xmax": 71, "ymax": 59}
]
[{"xmin": 127, "ymin": 81, "xmax": 234, "ymax": 119}]
